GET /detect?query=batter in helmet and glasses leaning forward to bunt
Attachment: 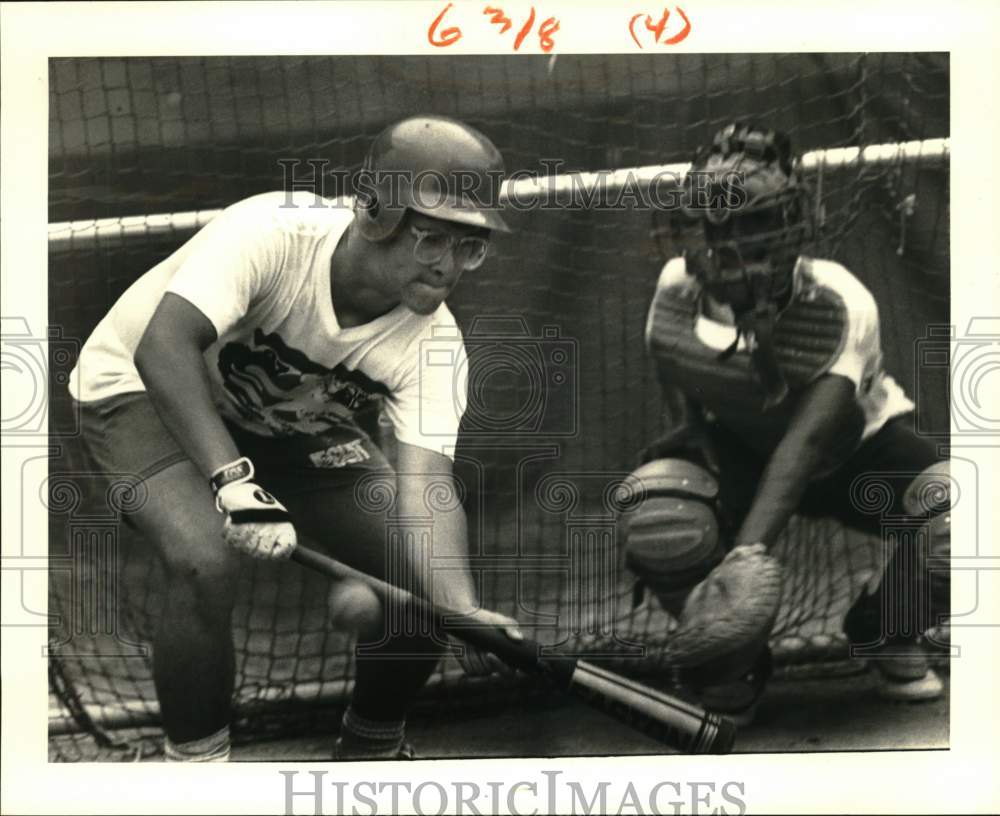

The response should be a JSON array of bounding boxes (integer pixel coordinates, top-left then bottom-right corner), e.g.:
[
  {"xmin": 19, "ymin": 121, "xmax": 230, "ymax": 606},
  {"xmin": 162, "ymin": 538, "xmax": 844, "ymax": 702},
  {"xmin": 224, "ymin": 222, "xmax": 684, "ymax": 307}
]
[{"xmin": 73, "ymin": 116, "xmax": 520, "ymax": 761}]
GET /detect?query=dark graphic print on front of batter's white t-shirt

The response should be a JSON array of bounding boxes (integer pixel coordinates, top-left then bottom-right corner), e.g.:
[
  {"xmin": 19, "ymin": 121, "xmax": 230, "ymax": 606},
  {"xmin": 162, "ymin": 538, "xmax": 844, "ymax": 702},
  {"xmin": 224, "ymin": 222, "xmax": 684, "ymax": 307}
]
[{"xmin": 218, "ymin": 329, "xmax": 389, "ymax": 436}]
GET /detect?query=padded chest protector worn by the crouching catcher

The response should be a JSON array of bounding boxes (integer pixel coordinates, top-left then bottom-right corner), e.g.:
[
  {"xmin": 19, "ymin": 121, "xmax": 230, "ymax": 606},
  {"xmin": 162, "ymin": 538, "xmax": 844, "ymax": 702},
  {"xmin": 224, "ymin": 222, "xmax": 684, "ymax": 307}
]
[{"xmin": 649, "ymin": 264, "xmax": 847, "ymax": 454}]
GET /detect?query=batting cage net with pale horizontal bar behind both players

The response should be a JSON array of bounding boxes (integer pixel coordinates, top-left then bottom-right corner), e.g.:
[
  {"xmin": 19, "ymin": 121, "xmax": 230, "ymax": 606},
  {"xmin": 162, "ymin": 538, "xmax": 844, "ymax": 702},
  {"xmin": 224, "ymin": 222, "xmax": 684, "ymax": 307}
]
[{"xmin": 42, "ymin": 54, "xmax": 949, "ymax": 760}]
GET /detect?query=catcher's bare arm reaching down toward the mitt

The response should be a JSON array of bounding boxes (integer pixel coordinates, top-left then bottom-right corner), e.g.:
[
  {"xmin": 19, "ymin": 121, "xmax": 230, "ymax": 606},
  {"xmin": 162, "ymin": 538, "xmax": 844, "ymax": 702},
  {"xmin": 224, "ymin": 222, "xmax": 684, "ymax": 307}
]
[{"xmin": 735, "ymin": 374, "xmax": 864, "ymax": 546}]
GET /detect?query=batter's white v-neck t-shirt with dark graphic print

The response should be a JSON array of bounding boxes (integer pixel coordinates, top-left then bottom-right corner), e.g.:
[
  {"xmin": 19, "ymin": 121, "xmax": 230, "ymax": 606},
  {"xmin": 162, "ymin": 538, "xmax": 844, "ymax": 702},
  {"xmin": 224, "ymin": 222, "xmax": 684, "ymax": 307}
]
[{"xmin": 70, "ymin": 192, "xmax": 467, "ymax": 456}]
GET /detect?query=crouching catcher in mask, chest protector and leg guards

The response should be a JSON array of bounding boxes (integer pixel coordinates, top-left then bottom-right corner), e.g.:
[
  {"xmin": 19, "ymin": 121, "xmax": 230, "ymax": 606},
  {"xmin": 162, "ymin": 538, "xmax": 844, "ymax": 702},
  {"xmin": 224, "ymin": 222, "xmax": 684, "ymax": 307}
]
[{"xmin": 624, "ymin": 124, "xmax": 950, "ymax": 723}]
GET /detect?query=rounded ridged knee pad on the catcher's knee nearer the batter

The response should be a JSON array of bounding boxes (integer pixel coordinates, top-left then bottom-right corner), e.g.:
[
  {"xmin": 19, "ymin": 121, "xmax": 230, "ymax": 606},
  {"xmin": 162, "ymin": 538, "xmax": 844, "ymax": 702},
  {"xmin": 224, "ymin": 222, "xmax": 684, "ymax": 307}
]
[{"xmin": 621, "ymin": 459, "xmax": 725, "ymax": 597}]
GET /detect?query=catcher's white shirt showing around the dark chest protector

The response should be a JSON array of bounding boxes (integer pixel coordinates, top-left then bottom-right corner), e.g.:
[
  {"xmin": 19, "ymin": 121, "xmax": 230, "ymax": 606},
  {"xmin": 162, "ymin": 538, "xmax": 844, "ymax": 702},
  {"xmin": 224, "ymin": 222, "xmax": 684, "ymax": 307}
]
[{"xmin": 664, "ymin": 257, "xmax": 913, "ymax": 439}]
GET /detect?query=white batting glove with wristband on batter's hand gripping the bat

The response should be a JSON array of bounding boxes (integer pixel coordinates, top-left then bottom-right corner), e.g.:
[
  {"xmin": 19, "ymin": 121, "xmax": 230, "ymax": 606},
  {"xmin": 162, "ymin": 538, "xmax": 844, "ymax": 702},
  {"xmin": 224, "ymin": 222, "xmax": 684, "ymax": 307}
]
[{"xmin": 211, "ymin": 456, "xmax": 297, "ymax": 559}]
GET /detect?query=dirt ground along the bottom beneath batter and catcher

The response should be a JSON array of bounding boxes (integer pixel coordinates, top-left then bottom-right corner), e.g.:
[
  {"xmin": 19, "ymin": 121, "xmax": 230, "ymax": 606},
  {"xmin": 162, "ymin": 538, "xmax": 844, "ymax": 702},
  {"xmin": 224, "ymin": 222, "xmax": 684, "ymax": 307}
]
[{"xmin": 233, "ymin": 674, "xmax": 949, "ymax": 761}]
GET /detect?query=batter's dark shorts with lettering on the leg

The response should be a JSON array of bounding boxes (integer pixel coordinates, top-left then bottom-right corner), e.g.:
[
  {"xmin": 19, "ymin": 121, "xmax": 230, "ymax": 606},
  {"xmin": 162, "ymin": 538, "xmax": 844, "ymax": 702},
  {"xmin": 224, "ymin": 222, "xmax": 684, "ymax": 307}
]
[{"xmin": 80, "ymin": 392, "xmax": 392, "ymax": 496}]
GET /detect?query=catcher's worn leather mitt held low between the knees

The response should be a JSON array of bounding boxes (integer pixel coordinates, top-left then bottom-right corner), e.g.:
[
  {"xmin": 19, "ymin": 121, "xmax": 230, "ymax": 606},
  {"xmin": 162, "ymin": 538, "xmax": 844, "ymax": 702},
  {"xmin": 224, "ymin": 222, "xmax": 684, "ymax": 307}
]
[{"xmin": 669, "ymin": 544, "xmax": 782, "ymax": 685}]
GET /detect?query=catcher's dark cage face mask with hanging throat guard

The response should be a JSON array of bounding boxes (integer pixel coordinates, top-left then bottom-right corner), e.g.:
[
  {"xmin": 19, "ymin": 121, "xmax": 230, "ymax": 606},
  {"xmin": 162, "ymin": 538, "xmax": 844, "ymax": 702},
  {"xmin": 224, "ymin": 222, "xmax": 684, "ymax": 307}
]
[{"xmin": 679, "ymin": 124, "xmax": 814, "ymax": 407}]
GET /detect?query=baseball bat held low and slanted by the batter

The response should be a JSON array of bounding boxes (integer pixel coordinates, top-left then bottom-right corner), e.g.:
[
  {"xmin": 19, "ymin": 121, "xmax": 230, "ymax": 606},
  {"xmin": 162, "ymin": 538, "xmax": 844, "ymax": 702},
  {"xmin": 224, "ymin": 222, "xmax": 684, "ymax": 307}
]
[{"xmin": 291, "ymin": 545, "xmax": 736, "ymax": 754}]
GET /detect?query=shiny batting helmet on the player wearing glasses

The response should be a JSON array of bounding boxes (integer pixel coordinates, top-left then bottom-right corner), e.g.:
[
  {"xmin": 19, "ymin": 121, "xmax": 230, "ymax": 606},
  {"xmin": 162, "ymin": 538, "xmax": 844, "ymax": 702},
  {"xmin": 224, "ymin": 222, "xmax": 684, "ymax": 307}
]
[{"xmin": 355, "ymin": 116, "xmax": 510, "ymax": 241}]
